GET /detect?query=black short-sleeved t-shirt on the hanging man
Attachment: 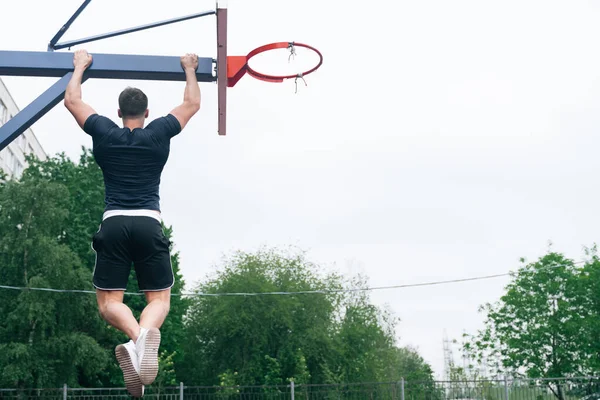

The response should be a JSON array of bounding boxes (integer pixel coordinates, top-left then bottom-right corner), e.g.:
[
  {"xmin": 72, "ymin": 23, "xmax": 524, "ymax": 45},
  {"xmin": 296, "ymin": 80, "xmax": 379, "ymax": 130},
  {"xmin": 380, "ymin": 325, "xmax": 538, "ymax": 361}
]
[{"xmin": 83, "ymin": 114, "xmax": 181, "ymax": 211}]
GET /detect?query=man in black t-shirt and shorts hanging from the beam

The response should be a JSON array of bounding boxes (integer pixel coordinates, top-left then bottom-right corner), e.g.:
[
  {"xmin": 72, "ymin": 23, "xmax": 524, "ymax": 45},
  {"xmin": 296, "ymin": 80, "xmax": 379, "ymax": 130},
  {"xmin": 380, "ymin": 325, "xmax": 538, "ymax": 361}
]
[{"xmin": 64, "ymin": 50, "xmax": 200, "ymax": 397}]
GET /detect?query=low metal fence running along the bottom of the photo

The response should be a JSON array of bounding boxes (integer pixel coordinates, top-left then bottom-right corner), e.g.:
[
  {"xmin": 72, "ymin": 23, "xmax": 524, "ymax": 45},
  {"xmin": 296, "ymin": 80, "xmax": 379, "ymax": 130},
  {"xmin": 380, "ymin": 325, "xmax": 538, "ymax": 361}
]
[{"xmin": 0, "ymin": 377, "xmax": 600, "ymax": 400}]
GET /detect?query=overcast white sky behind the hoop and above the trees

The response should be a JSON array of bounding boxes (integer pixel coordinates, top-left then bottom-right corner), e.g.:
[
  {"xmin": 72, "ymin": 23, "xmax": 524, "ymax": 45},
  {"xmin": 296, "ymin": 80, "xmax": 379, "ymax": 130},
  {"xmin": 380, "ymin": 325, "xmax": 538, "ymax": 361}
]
[{"xmin": 0, "ymin": 0, "xmax": 600, "ymax": 382}]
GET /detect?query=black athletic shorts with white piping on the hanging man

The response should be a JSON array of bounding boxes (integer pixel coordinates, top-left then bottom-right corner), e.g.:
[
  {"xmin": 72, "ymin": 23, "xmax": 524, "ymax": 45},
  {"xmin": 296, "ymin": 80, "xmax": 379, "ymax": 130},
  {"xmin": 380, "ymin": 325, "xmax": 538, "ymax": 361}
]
[{"xmin": 92, "ymin": 215, "xmax": 175, "ymax": 291}]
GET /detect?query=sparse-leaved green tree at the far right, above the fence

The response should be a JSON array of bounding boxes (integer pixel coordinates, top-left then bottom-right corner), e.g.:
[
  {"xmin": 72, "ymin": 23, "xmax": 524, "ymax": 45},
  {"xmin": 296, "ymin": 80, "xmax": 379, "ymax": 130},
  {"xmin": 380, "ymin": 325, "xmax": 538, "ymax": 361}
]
[{"xmin": 464, "ymin": 252, "xmax": 593, "ymax": 399}]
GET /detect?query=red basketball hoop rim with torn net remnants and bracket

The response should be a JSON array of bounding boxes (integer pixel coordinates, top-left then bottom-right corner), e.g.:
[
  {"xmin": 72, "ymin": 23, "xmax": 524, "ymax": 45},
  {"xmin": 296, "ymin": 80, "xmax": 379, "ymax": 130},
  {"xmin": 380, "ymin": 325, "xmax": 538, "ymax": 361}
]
[{"xmin": 227, "ymin": 42, "xmax": 323, "ymax": 87}]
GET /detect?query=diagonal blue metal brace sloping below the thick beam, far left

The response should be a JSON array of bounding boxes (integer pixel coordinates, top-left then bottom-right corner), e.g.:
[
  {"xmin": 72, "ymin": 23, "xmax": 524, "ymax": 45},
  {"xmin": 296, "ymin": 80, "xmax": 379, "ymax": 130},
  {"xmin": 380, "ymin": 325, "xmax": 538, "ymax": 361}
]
[{"xmin": 0, "ymin": 72, "xmax": 82, "ymax": 150}]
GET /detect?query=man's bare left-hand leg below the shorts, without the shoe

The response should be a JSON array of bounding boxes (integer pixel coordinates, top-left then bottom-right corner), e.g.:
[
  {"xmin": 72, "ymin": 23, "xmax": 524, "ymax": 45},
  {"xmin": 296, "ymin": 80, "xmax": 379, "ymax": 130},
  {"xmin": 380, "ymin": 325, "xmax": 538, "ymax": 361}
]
[{"xmin": 96, "ymin": 289, "xmax": 140, "ymax": 342}]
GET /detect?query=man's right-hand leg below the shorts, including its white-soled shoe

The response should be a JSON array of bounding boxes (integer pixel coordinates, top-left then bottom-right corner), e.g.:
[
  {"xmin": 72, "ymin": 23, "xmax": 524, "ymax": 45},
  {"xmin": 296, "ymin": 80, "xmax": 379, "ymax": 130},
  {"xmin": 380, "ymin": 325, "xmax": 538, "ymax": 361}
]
[{"xmin": 136, "ymin": 289, "xmax": 171, "ymax": 385}]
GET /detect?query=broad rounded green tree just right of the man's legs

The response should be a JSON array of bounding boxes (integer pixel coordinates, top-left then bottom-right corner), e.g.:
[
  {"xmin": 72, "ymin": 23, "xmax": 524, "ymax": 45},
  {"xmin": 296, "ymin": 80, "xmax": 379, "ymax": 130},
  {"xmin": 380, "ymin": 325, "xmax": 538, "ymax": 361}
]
[{"xmin": 183, "ymin": 251, "xmax": 340, "ymax": 385}]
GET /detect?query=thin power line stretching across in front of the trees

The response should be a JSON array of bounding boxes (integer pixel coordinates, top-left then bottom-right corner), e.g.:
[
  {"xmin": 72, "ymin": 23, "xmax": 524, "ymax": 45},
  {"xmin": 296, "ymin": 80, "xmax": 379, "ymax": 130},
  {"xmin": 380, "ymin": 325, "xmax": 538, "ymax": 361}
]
[{"xmin": 0, "ymin": 261, "xmax": 586, "ymax": 297}]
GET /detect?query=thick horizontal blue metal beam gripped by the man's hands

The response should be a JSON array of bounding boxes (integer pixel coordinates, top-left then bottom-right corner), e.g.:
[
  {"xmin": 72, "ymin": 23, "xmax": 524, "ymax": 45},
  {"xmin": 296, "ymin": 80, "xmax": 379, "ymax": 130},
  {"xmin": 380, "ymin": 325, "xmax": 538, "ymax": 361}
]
[{"xmin": 0, "ymin": 51, "xmax": 217, "ymax": 82}]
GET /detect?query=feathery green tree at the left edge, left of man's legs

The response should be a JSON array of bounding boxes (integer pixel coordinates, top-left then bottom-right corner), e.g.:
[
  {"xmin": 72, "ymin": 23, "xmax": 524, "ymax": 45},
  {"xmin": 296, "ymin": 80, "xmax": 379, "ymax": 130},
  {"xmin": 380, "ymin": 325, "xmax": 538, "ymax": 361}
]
[{"xmin": 0, "ymin": 180, "xmax": 109, "ymax": 387}]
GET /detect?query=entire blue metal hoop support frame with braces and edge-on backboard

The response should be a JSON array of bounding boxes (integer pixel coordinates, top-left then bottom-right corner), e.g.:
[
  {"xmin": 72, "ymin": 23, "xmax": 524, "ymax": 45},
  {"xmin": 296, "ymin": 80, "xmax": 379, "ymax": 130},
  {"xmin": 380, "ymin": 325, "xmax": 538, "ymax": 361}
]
[{"xmin": 0, "ymin": 0, "xmax": 227, "ymax": 150}]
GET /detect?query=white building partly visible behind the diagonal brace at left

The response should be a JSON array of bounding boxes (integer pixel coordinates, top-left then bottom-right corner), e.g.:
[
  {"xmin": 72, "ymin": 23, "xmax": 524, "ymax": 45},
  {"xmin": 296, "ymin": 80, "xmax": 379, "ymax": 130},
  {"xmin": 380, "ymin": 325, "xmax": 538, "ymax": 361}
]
[{"xmin": 0, "ymin": 79, "xmax": 47, "ymax": 179}]
